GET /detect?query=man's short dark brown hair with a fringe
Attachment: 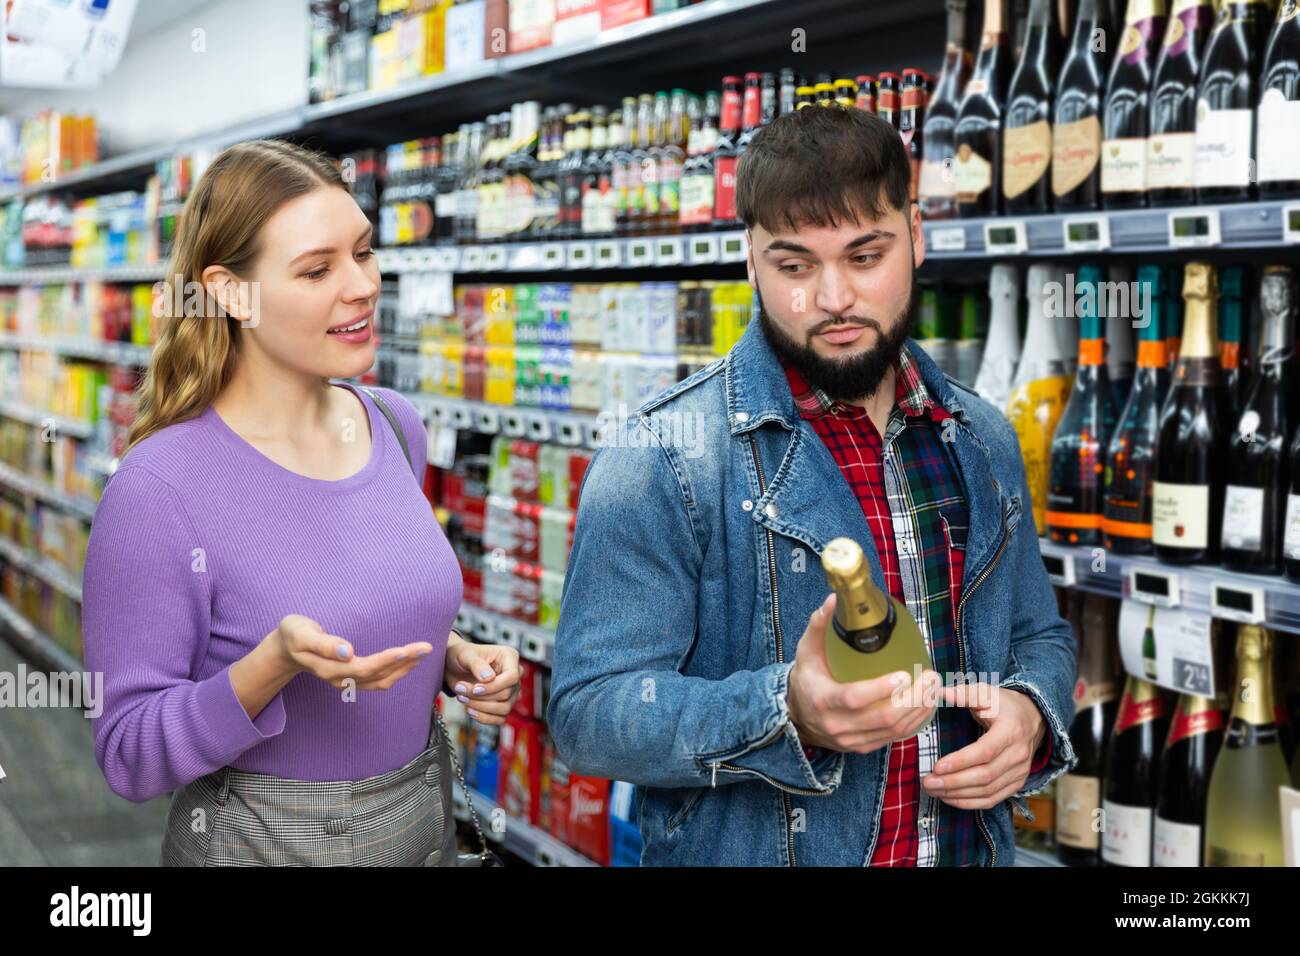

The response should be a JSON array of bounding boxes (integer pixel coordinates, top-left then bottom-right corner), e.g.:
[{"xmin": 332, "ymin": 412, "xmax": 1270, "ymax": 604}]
[{"xmin": 736, "ymin": 104, "xmax": 911, "ymax": 233}]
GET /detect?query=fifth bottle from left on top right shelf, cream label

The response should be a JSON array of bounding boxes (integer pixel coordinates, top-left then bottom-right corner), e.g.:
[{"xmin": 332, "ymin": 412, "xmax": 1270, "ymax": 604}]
[{"xmin": 1101, "ymin": 0, "xmax": 1165, "ymax": 209}]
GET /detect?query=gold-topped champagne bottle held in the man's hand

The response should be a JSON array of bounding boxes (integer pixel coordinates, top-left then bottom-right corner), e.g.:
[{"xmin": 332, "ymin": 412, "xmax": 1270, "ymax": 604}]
[{"xmin": 822, "ymin": 537, "xmax": 935, "ymax": 732}]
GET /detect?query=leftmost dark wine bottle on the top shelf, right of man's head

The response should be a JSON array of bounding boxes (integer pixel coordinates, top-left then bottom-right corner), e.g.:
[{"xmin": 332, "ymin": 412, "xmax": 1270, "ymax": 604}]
[{"xmin": 920, "ymin": 0, "xmax": 974, "ymax": 220}]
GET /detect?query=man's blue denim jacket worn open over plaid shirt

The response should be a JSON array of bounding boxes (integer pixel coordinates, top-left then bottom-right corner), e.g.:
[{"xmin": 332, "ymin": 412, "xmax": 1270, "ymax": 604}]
[{"xmin": 546, "ymin": 321, "xmax": 1076, "ymax": 866}]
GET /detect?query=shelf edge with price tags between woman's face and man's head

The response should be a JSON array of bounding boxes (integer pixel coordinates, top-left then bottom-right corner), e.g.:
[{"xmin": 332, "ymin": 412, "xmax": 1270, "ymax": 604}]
[{"xmin": 377, "ymin": 229, "xmax": 746, "ymax": 274}]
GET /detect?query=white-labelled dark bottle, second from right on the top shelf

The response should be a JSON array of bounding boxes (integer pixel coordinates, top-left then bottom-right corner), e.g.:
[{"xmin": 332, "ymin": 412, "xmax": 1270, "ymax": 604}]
[{"xmin": 1196, "ymin": 0, "xmax": 1269, "ymax": 203}]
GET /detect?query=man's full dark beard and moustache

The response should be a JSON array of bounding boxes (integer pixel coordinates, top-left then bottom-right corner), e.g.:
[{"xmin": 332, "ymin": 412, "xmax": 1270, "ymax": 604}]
[{"xmin": 754, "ymin": 261, "xmax": 918, "ymax": 403}]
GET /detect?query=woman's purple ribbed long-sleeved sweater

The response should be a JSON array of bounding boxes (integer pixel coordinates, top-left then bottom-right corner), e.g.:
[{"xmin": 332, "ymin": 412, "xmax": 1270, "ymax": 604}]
[{"xmin": 82, "ymin": 389, "xmax": 463, "ymax": 800}]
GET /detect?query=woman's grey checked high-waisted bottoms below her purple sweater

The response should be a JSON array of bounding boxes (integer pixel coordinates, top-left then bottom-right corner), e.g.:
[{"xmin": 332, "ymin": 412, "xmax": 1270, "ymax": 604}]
[{"xmin": 161, "ymin": 702, "xmax": 456, "ymax": 866}]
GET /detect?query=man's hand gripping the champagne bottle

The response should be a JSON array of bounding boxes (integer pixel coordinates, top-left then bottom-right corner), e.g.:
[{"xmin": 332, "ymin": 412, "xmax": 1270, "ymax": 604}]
[{"xmin": 785, "ymin": 591, "xmax": 943, "ymax": 753}]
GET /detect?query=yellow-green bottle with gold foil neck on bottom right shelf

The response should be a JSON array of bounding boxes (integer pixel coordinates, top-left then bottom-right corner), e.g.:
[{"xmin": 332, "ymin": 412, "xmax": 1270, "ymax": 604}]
[{"xmin": 1205, "ymin": 624, "xmax": 1291, "ymax": 866}]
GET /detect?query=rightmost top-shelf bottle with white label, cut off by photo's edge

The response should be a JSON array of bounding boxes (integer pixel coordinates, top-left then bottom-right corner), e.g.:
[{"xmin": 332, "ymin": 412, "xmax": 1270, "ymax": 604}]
[{"xmin": 1256, "ymin": 0, "xmax": 1300, "ymax": 199}]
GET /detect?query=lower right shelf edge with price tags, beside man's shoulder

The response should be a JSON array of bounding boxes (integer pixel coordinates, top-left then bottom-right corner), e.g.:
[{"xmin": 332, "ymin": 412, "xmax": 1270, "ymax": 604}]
[{"xmin": 1039, "ymin": 538, "xmax": 1300, "ymax": 633}]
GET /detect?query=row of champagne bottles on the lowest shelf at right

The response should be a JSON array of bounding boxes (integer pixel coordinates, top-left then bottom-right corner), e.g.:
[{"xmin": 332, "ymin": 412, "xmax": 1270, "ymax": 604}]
[{"xmin": 1015, "ymin": 589, "xmax": 1300, "ymax": 866}]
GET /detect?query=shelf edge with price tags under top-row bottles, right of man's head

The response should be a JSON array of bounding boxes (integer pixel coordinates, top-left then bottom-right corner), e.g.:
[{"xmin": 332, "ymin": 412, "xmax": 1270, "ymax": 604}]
[{"xmin": 926, "ymin": 200, "xmax": 1300, "ymax": 261}]
